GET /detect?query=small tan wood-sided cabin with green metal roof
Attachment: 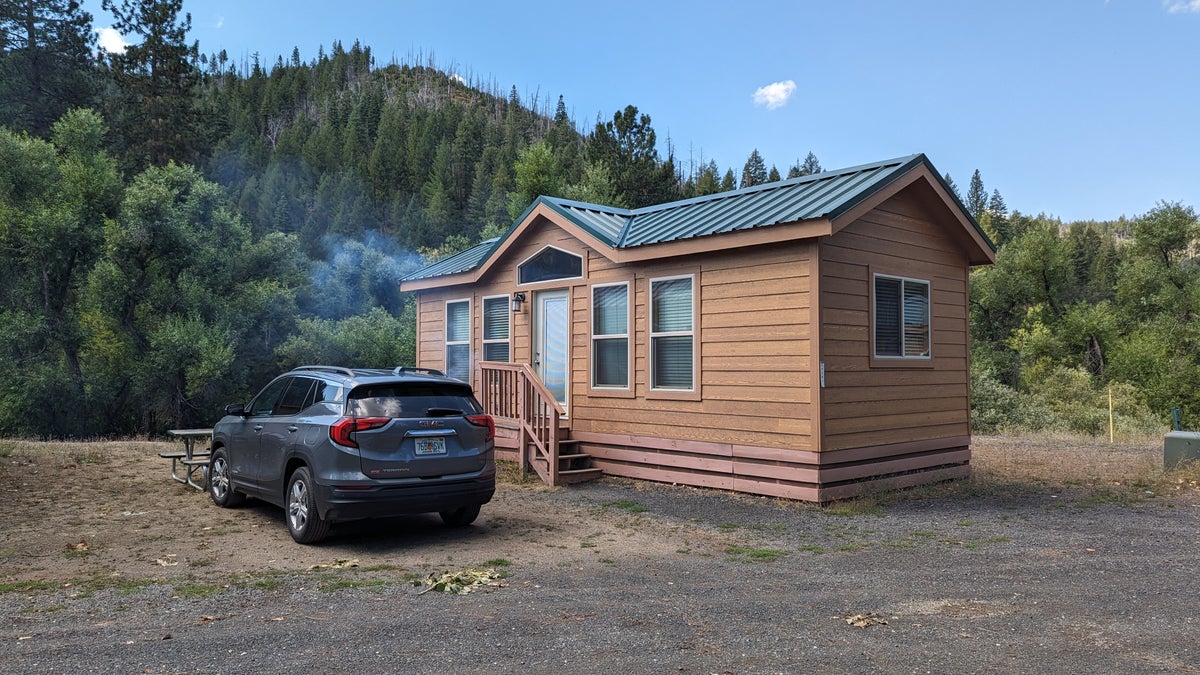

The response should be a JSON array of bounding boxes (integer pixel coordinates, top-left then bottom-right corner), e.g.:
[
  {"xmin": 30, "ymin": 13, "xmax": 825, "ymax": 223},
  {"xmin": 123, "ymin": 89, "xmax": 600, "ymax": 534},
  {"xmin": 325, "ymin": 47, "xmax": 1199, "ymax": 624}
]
[{"xmin": 401, "ymin": 155, "xmax": 995, "ymax": 502}]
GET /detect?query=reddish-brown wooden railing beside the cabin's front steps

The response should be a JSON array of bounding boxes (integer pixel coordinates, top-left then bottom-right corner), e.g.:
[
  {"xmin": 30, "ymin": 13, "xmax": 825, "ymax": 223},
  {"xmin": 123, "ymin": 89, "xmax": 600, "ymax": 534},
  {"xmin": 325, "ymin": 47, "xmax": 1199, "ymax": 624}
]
[{"xmin": 479, "ymin": 362, "xmax": 564, "ymax": 485}]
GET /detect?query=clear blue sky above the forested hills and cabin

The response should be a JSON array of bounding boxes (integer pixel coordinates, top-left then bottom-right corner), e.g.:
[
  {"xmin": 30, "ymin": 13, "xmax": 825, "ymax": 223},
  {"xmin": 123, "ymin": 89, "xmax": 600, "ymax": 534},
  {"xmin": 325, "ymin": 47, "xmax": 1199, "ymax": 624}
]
[{"xmin": 84, "ymin": 0, "xmax": 1200, "ymax": 221}]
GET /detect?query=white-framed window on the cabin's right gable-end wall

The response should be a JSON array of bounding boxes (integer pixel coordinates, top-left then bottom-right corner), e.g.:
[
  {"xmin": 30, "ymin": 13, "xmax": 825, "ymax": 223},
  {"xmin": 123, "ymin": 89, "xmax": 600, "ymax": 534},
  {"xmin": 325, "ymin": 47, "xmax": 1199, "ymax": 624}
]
[{"xmin": 875, "ymin": 274, "xmax": 930, "ymax": 359}]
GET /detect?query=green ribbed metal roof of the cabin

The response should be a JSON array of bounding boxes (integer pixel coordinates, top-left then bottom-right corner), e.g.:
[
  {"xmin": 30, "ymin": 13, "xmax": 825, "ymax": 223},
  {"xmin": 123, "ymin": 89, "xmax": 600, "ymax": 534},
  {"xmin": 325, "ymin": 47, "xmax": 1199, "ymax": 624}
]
[{"xmin": 406, "ymin": 155, "xmax": 995, "ymax": 281}]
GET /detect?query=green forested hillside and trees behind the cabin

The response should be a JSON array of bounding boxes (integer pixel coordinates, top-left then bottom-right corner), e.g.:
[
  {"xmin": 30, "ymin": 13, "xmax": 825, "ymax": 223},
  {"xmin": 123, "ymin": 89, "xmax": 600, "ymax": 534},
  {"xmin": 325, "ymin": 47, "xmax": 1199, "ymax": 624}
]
[{"xmin": 0, "ymin": 0, "xmax": 1200, "ymax": 437}]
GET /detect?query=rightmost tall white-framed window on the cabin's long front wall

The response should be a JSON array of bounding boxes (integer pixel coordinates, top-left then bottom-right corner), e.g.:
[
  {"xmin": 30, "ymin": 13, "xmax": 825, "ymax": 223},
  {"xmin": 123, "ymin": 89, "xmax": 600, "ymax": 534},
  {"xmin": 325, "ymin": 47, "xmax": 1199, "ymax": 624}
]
[{"xmin": 650, "ymin": 276, "xmax": 695, "ymax": 392}]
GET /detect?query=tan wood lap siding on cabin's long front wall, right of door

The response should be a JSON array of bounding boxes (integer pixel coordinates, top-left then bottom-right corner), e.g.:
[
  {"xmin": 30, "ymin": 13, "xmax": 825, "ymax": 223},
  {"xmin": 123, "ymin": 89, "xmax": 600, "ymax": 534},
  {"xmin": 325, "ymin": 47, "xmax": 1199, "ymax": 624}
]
[{"xmin": 571, "ymin": 244, "xmax": 814, "ymax": 451}]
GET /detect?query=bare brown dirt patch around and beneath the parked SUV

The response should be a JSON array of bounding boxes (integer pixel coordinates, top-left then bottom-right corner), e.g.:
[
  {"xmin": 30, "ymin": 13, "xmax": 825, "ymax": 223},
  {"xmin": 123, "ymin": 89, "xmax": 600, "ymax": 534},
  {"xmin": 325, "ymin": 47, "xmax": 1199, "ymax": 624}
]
[{"xmin": 0, "ymin": 442, "xmax": 715, "ymax": 583}]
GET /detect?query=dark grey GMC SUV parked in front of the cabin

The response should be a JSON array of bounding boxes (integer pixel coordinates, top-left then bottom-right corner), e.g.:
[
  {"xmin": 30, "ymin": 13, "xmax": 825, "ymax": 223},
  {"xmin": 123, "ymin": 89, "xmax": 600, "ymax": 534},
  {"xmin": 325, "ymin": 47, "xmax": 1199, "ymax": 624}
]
[{"xmin": 208, "ymin": 365, "xmax": 496, "ymax": 544}]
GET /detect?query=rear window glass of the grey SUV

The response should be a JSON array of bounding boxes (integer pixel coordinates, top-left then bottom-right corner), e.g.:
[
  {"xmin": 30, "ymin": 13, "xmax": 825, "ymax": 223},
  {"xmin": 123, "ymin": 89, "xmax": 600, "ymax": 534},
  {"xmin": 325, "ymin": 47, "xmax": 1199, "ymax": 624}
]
[{"xmin": 346, "ymin": 382, "xmax": 480, "ymax": 418}]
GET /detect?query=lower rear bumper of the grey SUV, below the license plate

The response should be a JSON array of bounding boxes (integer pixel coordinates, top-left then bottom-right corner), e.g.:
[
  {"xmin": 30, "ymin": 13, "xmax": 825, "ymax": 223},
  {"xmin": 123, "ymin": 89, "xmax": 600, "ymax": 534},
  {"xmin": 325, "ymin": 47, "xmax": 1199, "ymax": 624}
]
[{"xmin": 316, "ymin": 473, "xmax": 496, "ymax": 522}]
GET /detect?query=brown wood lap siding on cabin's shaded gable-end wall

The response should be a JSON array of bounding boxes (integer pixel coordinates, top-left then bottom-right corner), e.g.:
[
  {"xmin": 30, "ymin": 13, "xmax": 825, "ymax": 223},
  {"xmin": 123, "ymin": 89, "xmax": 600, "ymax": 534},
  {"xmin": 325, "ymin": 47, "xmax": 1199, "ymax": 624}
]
[{"xmin": 821, "ymin": 193, "xmax": 971, "ymax": 452}]
